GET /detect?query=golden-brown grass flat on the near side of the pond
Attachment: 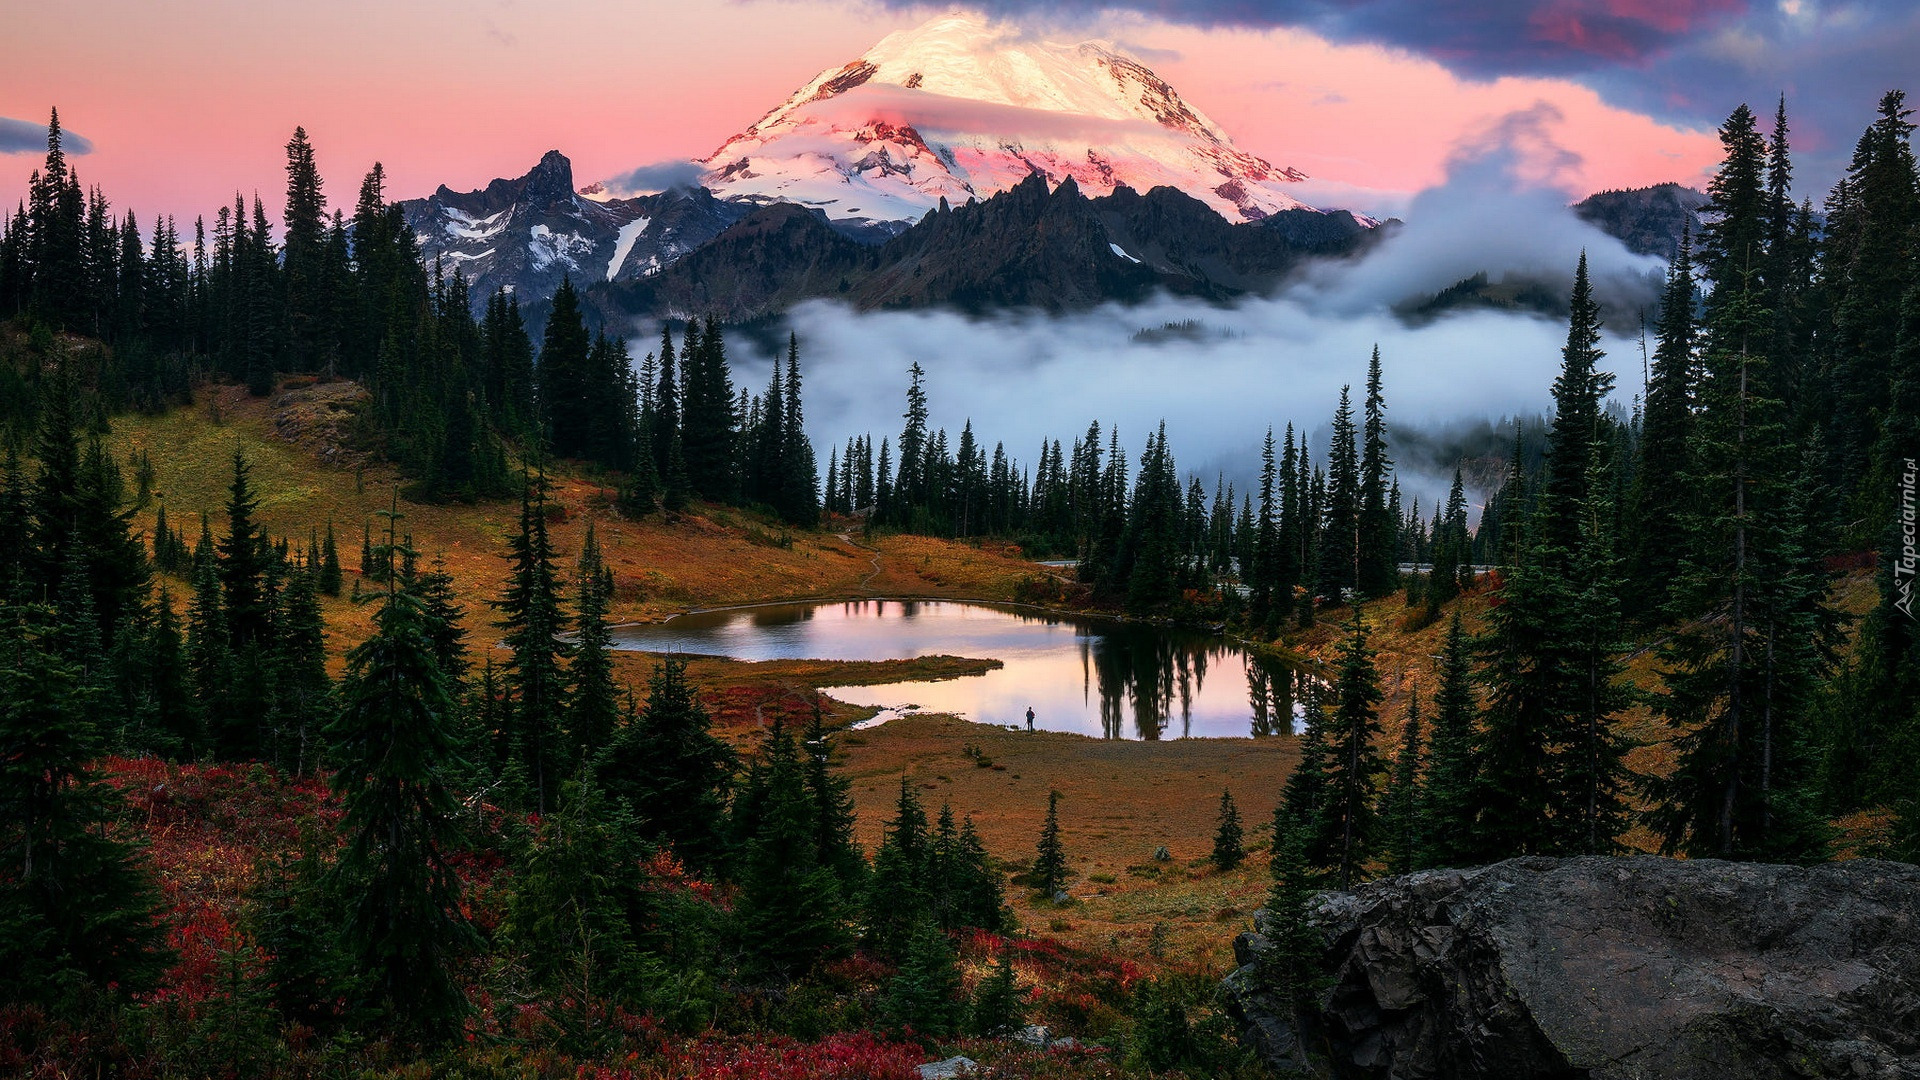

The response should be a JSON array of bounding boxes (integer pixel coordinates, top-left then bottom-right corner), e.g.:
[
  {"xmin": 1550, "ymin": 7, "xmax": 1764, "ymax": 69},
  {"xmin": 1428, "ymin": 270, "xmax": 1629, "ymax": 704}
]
[{"xmin": 841, "ymin": 715, "xmax": 1298, "ymax": 963}]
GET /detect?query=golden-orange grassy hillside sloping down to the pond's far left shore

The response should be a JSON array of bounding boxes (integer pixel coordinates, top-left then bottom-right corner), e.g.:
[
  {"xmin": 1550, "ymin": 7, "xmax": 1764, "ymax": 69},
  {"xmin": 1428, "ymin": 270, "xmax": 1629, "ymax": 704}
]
[{"xmin": 109, "ymin": 386, "xmax": 1033, "ymax": 653}]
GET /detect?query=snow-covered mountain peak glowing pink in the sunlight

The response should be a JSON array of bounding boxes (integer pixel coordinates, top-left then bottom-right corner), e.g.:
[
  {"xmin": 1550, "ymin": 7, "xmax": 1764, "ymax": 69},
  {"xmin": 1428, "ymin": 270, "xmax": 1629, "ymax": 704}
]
[{"xmin": 701, "ymin": 13, "xmax": 1304, "ymax": 223}]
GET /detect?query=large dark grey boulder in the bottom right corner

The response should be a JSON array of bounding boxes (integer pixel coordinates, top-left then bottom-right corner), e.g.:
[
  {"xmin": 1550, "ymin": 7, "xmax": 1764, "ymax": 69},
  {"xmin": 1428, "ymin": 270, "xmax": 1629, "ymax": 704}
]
[{"xmin": 1227, "ymin": 857, "xmax": 1920, "ymax": 1080}]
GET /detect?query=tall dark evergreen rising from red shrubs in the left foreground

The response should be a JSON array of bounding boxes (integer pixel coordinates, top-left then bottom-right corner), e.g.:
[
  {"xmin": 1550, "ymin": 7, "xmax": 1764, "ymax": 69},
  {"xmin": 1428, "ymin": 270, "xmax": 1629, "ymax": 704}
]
[{"xmin": 326, "ymin": 513, "xmax": 480, "ymax": 1042}]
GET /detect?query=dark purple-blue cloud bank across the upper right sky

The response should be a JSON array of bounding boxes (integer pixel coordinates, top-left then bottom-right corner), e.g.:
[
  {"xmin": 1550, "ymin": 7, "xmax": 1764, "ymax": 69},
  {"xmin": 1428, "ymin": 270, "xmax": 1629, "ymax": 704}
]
[{"xmin": 876, "ymin": 0, "xmax": 1920, "ymax": 191}]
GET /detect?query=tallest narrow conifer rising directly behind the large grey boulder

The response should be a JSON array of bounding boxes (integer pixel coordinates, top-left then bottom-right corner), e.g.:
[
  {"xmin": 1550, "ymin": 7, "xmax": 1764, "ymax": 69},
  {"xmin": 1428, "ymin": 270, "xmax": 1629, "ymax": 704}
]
[{"xmin": 1647, "ymin": 106, "xmax": 1824, "ymax": 861}]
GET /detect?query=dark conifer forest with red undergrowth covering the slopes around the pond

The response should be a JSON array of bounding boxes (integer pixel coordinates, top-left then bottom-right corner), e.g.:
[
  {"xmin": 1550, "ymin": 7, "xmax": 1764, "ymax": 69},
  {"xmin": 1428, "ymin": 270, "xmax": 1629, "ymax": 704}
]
[{"xmin": 0, "ymin": 92, "xmax": 1920, "ymax": 1076}]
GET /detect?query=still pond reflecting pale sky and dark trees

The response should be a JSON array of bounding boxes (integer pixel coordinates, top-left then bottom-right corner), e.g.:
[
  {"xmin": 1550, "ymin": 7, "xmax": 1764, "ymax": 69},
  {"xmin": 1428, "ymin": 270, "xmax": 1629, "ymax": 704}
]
[{"xmin": 614, "ymin": 600, "xmax": 1306, "ymax": 740}]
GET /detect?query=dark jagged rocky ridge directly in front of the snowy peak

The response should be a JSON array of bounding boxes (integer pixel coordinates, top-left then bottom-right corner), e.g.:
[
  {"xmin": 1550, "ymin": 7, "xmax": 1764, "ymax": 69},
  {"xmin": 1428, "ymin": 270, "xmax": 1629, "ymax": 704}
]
[{"xmin": 591, "ymin": 175, "xmax": 1380, "ymax": 321}]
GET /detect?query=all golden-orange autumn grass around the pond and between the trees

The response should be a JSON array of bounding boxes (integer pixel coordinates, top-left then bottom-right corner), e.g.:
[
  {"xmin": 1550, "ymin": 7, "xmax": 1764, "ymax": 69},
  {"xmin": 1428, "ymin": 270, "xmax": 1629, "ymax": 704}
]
[{"xmin": 97, "ymin": 388, "xmax": 1876, "ymax": 970}]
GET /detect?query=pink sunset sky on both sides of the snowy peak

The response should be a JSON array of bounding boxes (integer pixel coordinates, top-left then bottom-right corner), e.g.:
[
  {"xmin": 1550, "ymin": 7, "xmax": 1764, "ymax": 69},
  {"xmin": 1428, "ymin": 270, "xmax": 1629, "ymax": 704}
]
[{"xmin": 0, "ymin": 0, "xmax": 1904, "ymax": 221}]
